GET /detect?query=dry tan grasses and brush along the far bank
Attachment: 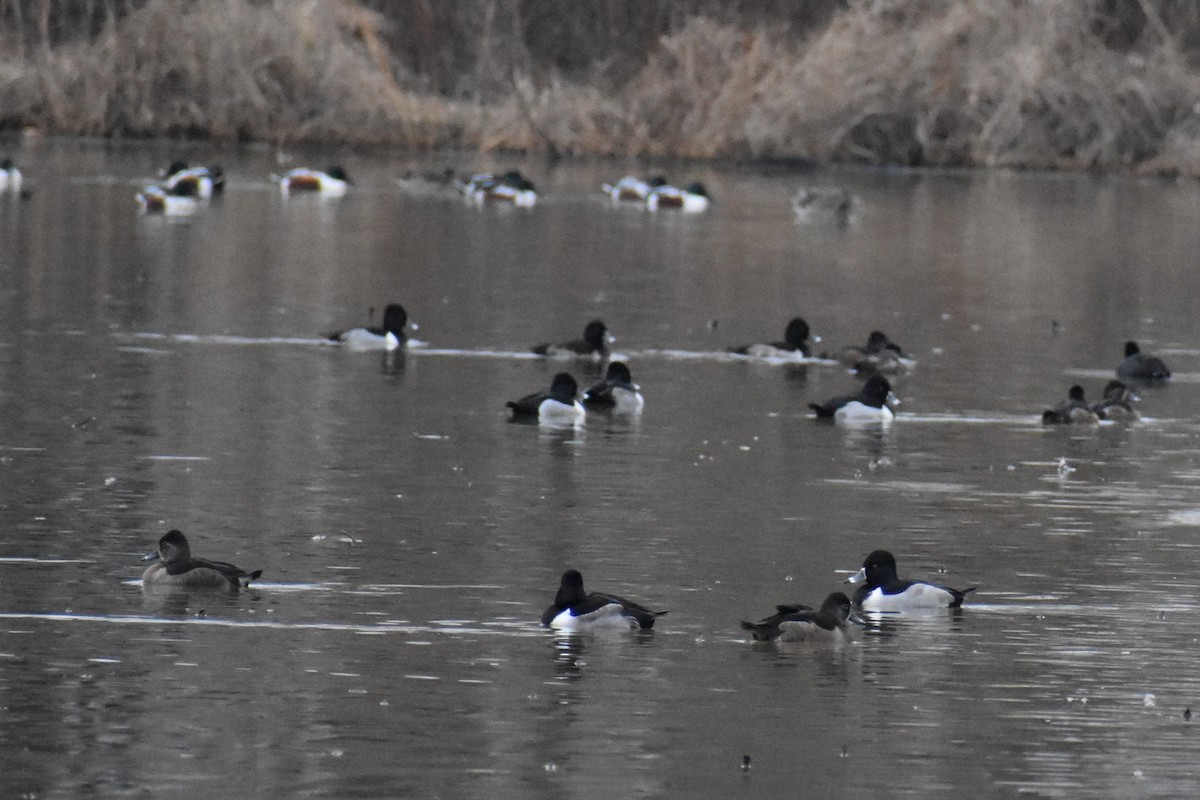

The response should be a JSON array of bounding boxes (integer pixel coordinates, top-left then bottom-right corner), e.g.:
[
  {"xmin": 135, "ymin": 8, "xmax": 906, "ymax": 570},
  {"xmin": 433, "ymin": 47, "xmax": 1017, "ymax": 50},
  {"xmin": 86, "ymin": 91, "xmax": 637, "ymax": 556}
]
[{"xmin": 0, "ymin": 0, "xmax": 1200, "ymax": 175}]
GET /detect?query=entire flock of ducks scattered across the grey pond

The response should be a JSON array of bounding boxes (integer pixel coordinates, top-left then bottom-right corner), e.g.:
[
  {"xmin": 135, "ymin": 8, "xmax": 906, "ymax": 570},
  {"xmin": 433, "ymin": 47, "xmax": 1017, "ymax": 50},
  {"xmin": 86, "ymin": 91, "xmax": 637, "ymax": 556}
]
[{"xmin": 0, "ymin": 153, "xmax": 1171, "ymax": 640}]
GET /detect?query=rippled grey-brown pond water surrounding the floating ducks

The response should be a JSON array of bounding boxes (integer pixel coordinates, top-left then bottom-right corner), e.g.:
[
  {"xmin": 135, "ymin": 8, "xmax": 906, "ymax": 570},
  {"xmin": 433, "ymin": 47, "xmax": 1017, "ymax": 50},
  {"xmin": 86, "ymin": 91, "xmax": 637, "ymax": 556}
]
[{"xmin": 0, "ymin": 140, "xmax": 1200, "ymax": 799}]
